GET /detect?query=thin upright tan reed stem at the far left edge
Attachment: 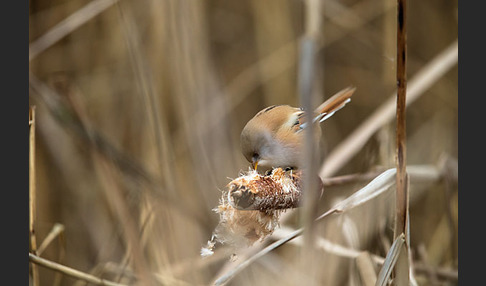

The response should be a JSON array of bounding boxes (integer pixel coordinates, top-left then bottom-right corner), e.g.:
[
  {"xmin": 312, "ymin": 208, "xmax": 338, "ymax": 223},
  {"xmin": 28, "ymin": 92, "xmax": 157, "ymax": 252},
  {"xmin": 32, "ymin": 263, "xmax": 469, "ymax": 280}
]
[{"xmin": 29, "ymin": 106, "xmax": 39, "ymax": 286}]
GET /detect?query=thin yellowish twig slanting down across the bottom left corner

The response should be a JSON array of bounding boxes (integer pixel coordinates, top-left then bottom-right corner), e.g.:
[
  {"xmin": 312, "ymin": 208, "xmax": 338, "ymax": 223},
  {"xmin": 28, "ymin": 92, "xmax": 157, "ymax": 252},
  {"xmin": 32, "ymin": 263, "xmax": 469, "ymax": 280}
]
[{"xmin": 29, "ymin": 253, "xmax": 124, "ymax": 286}]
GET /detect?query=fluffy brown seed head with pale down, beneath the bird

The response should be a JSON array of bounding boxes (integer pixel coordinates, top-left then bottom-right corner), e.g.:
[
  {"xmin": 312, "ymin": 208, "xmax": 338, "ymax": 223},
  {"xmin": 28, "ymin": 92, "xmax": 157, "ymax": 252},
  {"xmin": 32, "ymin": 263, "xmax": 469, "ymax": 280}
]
[{"xmin": 201, "ymin": 168, "xmax": 301, "ymax": 257}]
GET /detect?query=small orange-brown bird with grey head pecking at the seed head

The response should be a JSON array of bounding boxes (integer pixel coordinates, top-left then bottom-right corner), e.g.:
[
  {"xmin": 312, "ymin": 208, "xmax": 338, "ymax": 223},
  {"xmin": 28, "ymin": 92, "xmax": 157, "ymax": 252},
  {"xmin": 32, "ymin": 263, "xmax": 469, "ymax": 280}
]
[{"xmin": 240, "ymin": 87, "xmax": 356, "ymax": 170}]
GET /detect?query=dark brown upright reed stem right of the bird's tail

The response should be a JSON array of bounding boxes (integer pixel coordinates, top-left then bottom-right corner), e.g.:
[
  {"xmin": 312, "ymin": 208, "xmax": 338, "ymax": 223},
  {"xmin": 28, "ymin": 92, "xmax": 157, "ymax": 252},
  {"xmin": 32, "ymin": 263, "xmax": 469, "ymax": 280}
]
[{"xmin": 394, "ymin": 0, "xmax": 408, "ymax": 239}]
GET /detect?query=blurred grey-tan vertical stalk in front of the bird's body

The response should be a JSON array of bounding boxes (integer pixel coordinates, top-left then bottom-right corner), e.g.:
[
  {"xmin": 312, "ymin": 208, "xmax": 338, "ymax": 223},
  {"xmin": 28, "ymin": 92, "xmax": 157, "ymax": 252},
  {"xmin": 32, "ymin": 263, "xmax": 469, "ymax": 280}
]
[{"xmin": 297, "ymin": 0, "xmax": 323, "ymax": 278}]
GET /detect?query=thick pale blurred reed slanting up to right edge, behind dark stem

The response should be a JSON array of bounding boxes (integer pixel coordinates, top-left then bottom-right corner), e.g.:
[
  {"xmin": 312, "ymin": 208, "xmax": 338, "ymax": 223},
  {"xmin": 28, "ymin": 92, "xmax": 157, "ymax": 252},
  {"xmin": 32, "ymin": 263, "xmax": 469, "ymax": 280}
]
[{"xmin": 319, "ymin": 39, "xmax": 458, "ymax": 178}]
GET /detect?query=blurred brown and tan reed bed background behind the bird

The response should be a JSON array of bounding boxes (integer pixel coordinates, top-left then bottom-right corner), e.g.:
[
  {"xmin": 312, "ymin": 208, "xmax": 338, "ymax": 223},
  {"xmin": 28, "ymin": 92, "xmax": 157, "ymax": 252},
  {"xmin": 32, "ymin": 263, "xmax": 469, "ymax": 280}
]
[{"xmin": 29, "ymin": 0, "xmax": 458, "ymax": 285}]
